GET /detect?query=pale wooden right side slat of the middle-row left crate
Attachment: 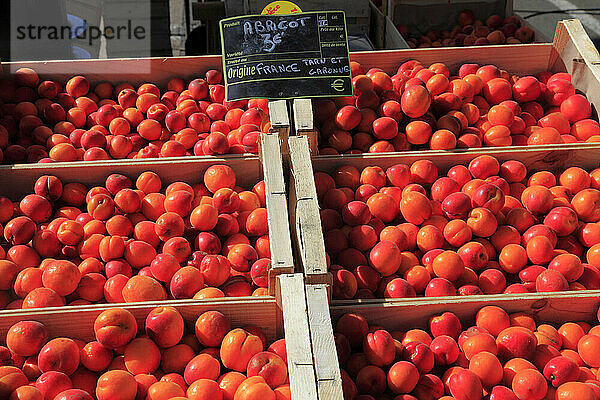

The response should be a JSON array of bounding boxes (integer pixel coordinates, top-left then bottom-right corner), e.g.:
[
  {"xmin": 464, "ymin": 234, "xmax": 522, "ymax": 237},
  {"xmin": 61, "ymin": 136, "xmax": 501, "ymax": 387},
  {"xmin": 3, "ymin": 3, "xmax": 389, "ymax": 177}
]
[{"xmin": 260, "ymin": 133, "xmax": 294, "ymax": 295}]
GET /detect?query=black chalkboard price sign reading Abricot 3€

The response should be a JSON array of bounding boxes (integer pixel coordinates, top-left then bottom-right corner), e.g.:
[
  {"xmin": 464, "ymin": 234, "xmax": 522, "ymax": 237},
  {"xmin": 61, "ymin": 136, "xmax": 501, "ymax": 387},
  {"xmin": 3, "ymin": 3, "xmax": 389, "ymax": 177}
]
[{"xmin": 220, "ymin": 11, "xmax": 352, "ymax": 101}]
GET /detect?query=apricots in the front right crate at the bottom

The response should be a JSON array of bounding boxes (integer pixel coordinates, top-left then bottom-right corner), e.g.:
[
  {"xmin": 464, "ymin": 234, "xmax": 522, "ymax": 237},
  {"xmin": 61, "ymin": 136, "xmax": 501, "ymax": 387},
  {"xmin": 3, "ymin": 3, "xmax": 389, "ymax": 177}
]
[{"xmin": 335, "ymin": 306, "xmax": 600, "ymax": 400}]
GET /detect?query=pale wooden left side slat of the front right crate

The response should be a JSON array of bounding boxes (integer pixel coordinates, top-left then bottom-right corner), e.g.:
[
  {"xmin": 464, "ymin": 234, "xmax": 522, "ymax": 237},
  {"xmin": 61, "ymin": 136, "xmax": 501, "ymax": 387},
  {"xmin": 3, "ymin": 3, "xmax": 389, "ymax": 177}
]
[{"xmin": 306, "ymin": 285, "xmax": 344, "ymax": 400}]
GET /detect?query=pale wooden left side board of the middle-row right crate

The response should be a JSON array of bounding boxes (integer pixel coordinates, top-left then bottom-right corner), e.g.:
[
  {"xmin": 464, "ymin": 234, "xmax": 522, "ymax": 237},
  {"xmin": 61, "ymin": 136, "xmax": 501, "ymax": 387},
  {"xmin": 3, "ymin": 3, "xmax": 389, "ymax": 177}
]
[{"xmin": 288, "ymin": 136, "xmax": 332, "ymax": 284}]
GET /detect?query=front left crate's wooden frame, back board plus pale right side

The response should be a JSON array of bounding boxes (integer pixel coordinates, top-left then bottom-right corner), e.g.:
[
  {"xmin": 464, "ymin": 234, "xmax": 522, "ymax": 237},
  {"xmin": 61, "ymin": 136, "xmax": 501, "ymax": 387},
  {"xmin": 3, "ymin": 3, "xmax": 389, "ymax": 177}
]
[{"xmin": 0, "ymin": 274, "xmax": 324, "ymax": 400}]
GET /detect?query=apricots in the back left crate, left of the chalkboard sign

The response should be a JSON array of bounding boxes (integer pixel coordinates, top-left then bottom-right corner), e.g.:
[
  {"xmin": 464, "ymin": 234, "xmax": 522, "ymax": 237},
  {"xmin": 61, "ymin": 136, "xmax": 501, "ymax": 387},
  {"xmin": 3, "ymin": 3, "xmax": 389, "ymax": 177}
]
[{"xmin": 0, "ymin": 68, "xmax": 270, "ymax": 164}]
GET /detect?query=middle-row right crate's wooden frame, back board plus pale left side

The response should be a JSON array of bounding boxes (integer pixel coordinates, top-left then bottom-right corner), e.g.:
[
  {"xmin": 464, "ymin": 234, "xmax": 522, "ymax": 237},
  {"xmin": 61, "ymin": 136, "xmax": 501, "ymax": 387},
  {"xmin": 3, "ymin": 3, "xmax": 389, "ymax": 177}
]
[{"xmin": 289, "ymin": 135, "xmax": 600, "ymax": 290}]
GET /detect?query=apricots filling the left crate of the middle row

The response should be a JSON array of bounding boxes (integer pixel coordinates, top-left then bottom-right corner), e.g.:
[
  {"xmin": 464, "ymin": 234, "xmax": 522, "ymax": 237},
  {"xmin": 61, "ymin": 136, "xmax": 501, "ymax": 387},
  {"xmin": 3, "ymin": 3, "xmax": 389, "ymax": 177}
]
[{"xmin": 0, "ymin": 164, "xmax": 270, "ymax": 309}]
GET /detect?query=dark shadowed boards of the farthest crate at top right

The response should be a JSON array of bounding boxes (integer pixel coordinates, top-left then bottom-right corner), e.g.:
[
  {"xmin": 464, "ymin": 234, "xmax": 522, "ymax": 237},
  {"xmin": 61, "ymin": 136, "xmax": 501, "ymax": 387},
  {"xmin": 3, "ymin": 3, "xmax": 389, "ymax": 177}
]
[{"xmin": 384, "ymin": 0, "xmax": 550, "ymax": 43}]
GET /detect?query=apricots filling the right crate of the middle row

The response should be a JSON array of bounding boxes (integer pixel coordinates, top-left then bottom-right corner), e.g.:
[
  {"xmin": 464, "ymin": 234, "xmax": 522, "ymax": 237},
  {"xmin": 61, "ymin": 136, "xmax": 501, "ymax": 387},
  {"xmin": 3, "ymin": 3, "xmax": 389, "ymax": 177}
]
[{"xmin": 315, "ymin": 155, "xmax": 600, "ymax": 299}]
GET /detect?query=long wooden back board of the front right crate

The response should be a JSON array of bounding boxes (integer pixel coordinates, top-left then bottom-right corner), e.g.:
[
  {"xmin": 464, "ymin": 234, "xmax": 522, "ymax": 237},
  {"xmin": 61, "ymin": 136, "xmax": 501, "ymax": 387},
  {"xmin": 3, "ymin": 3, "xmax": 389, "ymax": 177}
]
[{"xmin": 331, "ymin": 290, "xmax": 600, "ymax": 330}]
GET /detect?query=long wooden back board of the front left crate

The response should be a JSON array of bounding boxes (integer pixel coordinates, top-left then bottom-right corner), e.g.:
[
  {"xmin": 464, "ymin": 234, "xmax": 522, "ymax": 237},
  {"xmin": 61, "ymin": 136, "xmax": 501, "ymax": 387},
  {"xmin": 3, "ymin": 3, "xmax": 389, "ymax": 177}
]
[{"xmin": 0, "ymin": 297, "xmax": 280, "ymax": 344}]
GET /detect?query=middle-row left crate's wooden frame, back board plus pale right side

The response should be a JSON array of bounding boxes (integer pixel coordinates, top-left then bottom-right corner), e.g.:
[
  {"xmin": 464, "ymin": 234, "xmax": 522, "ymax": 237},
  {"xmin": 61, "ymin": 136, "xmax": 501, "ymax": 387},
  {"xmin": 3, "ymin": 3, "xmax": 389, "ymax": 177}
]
[{"xmin": 0, "ymin": 133, "xmax": 294, "ymax": 295}]
